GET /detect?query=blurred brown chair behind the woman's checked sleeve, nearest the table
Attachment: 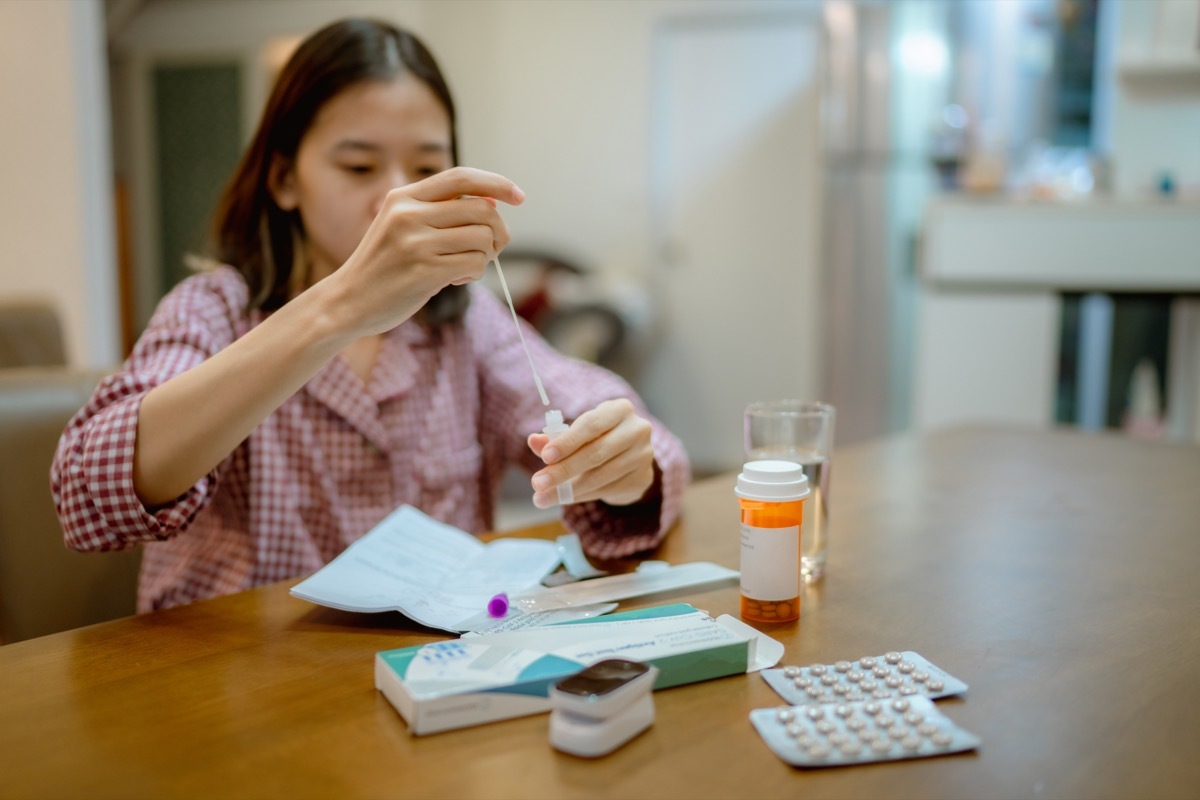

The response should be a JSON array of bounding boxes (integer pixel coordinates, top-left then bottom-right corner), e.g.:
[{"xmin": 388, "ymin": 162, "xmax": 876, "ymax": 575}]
[{"xmin": 0, "ymin": 367, "xmax": 140, "ymax": 643}]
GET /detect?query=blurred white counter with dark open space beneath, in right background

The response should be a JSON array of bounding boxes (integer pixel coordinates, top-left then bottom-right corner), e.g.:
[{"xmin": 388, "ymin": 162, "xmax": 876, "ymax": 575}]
[{"xmin": 913, "ymin": 198, "xmax": 1200, "ymax": 438}]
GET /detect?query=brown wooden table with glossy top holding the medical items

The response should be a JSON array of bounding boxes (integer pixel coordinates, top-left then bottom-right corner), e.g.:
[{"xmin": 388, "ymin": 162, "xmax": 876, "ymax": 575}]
[{"xmin": 0, "ymin": 428, "xmax": 1200, "ymax": 799}]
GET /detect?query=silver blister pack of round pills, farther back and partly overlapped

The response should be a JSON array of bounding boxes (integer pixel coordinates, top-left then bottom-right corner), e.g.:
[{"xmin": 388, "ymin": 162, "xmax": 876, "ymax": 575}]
[{"xmin": 762, "ymin": 650, "xmax": 967, "ymax": 705}]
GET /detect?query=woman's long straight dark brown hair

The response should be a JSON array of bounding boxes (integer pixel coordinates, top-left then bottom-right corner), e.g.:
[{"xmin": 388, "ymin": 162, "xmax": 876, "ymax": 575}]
[{"xmin": 212, "ymin": 19, "xmax": 468, "ymax": 325}]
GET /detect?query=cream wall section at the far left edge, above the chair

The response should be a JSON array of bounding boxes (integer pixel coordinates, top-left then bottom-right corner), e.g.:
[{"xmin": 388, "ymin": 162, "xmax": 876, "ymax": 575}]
[{"xmin": 0, "ymin": 1, "xmax": 121, "ymax": 365}]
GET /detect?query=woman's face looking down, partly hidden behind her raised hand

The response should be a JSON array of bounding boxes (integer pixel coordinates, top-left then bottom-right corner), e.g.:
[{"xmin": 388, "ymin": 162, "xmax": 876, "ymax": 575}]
[{"xmin": 271, "ymin": 74, "xmax": 454, "ymax": 284}]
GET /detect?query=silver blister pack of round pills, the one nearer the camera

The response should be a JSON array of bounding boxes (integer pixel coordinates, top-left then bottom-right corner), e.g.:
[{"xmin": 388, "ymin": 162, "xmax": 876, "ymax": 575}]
[{"xmin": 750, "ymin": 696, "xmax": 980, "ymax": 768}]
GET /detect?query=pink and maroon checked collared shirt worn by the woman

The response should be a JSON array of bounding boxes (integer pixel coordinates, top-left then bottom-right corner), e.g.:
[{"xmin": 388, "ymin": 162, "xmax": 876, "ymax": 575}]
[{"xmin": 50, "ymin": 266, "xmax": 689, "ymax": 612}]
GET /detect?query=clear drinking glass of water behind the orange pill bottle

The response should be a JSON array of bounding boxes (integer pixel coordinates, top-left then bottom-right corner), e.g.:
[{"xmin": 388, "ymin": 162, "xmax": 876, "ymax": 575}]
[{"xmin": 743, "ymin": 399, "xmax": 836, "ymax": 583}]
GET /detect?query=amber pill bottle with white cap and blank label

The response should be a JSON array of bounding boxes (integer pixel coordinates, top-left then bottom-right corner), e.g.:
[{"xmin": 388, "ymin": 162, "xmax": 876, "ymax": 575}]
[{"xmin": 734, "ymin": 461, "xmax": 809, "ymax": 622}]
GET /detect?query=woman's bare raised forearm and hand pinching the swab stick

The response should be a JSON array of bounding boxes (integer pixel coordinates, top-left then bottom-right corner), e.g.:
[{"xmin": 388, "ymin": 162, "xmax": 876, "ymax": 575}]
[{"xmin": 133, "ymin": 167, "xmax": 524, "ymax": 507}]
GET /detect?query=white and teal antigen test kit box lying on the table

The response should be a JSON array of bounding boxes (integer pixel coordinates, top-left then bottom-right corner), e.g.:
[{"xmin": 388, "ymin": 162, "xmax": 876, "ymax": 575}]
[{"xmin": 374, "ymin": 603, "xmax": 782, "ymax": 735}]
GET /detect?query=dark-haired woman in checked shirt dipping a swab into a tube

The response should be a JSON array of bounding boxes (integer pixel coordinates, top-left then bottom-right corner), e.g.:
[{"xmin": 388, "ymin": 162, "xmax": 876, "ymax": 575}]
[{"xmin": 50, "ymin": 19, "xmax": 688, "ymax": 612}]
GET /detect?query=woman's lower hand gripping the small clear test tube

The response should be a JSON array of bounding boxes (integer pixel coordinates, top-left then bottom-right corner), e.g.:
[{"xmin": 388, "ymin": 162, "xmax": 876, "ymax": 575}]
[{"xmin": 529, "ymin": 398, "xmax": 654, "ymax": 509}]
